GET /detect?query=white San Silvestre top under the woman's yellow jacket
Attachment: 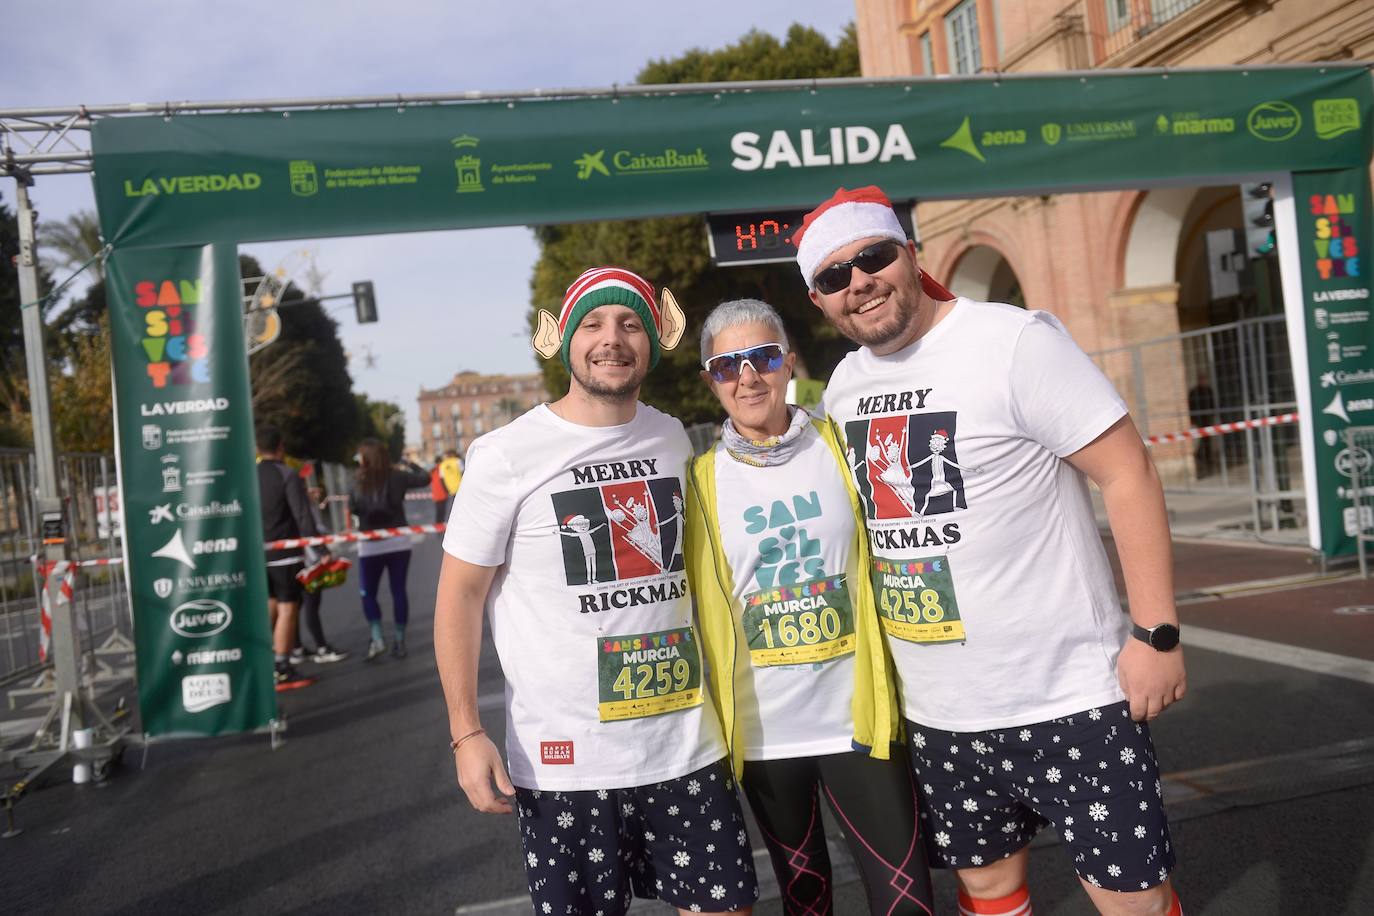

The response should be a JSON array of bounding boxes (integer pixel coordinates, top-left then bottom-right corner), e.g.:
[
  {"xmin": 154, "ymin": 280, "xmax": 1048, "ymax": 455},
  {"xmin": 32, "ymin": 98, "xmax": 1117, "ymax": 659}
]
[{"xmin": 714, "ymin": 424, "xmax": 864, "ymax": 759}]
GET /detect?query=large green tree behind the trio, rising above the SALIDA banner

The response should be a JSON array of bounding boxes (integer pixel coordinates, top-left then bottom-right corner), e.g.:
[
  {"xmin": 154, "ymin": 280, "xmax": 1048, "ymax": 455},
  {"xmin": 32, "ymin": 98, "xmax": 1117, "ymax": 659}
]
[{"xmin": 529, "ymin": 25, "xmax": 859, "ymax": 424}]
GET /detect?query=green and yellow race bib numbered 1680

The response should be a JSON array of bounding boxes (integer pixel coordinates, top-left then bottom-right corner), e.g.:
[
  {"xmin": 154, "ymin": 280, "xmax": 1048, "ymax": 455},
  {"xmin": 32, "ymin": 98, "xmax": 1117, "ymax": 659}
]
[{"xmin": 742, "ymin": 575, "xmax": 855, "ymax": 667}]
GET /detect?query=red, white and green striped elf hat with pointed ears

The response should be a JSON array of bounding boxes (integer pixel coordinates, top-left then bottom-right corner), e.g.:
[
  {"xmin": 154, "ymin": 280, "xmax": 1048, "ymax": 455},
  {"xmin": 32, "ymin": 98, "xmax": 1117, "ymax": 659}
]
[{"xmin": 533, "ymin": 268, "xmax": 687, "ymax": 372}]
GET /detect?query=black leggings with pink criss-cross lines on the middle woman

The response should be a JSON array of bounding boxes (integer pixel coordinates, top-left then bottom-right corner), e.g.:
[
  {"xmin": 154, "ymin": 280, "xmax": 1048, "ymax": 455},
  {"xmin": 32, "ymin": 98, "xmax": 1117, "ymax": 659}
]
[{"xmin": 743, "ymin": 744, "xmax": 933, "ymax": 916}]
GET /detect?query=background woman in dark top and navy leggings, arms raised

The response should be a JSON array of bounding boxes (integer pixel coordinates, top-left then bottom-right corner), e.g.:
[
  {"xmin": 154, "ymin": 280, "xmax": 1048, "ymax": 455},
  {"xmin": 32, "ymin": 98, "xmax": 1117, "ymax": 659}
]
[{"xmin": 349, "ymin": 439, "xmax": 430, "ymax": 661}]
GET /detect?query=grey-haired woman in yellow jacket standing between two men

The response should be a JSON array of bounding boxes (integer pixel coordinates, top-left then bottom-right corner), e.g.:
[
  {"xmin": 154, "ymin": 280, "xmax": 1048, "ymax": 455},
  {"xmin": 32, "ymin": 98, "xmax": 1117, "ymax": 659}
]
[{"xmin": 687, "ymin": 299, "xmax": 932, "ymax": 916}]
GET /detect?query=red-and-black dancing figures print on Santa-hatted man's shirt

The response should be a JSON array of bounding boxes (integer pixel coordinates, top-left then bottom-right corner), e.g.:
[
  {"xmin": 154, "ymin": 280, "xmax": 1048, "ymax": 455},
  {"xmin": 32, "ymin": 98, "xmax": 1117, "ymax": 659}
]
[{"xmin": 845, "ymin": 411, "xmax": 976, "ymax": 519}]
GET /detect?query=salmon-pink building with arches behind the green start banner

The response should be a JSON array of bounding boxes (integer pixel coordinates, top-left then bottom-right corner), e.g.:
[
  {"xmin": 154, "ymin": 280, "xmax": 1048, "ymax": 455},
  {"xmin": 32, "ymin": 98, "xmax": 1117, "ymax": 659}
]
[{"xmin": 856, "ymin": 0, "xmax": 1374, "ymax": 486}]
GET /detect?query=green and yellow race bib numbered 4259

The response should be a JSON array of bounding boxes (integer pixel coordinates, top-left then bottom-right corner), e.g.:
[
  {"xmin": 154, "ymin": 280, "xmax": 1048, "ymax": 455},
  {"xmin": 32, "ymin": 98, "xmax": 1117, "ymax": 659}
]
[{"xmin": 596, "ymin": 626, "xmax": 702, "ymax": 722}]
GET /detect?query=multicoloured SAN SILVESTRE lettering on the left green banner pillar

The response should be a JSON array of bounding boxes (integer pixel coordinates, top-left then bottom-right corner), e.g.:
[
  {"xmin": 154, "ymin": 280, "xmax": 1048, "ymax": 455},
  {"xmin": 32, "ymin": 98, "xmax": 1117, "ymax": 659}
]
[{"xmin": 133, "ymin": 279, "xmax": 210, "ymax": 389}]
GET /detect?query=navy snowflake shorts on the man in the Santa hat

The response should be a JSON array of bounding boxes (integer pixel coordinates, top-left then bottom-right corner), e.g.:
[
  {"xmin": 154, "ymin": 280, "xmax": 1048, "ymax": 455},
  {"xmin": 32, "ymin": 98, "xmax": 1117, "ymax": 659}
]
[{"xmin": 907, "ymin": 702, "xmax": 1175, "ymax": 891}]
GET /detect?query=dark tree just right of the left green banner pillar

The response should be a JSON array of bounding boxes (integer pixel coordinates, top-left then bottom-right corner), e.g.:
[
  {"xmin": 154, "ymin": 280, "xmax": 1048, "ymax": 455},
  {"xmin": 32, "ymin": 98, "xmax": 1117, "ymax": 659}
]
[{"xmin": 239, "ymin": 255, "xmax": 359, "ymax": 461}]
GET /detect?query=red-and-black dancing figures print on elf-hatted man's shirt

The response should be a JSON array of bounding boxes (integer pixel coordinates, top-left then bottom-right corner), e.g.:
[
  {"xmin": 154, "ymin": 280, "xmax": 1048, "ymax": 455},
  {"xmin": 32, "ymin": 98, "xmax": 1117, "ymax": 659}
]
[{"xmin": 552, "ymin": 478, "xmax": 683, "ymax": 585}]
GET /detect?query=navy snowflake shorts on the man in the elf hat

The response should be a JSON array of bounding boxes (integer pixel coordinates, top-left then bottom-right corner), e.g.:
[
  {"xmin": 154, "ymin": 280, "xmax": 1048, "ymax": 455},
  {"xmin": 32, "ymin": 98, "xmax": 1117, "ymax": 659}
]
[{"xmin": 515, "ymin": 759, "xmax": 758, "ymax": 916}]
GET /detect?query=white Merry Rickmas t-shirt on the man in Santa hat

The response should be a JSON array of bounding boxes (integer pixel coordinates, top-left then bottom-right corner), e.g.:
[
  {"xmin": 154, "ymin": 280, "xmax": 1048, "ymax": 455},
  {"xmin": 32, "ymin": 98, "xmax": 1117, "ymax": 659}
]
[{"xmin": 826, "ymin": 298, "xmax": 1128, "ymax": 731}]
